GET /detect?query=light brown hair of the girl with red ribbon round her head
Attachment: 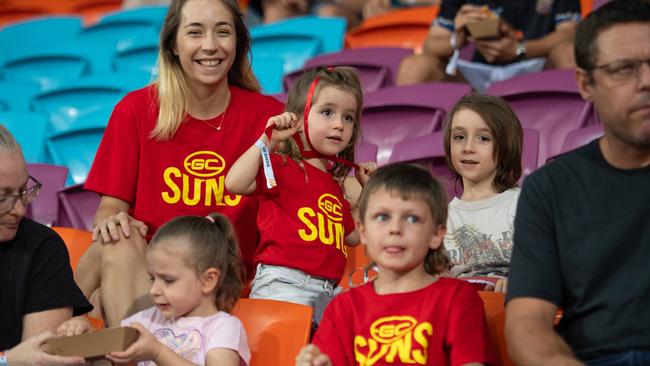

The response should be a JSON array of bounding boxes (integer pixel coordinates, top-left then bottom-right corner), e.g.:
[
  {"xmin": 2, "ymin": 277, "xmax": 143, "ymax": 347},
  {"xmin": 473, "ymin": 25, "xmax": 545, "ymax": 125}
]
[{"xmin": 277, "ymin": 66, "xmax": 363, "ymax": 180}]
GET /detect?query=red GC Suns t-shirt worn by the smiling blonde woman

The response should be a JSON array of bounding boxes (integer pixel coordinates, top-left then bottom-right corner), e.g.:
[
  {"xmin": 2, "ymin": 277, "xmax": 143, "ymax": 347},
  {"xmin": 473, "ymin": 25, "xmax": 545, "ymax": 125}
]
[{"xmin": 85, "ymin": 86, "xmax": 283, "ymax": 269}]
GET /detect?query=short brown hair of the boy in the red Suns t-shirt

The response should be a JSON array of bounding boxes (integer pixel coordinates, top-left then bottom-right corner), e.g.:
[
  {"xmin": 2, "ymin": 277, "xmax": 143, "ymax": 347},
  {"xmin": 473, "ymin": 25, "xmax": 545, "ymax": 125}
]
[{"xmin": 359, "ymin": 163, "xmax": 450, "ymax": 275}]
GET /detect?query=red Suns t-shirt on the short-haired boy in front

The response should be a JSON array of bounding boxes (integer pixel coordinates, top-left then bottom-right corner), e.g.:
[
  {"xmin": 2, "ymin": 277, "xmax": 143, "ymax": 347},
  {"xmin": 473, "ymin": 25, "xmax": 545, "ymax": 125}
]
[{"xmin": 313, "ymin": 278, "xmax": 495, "ymax": 366}]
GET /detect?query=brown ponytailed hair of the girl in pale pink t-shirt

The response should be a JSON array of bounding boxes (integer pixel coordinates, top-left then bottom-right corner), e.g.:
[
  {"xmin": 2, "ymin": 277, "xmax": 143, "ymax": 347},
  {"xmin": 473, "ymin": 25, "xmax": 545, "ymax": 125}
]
[{"xmin": 147, "ymin": 213, "xmax": 244, "ymax": 313}]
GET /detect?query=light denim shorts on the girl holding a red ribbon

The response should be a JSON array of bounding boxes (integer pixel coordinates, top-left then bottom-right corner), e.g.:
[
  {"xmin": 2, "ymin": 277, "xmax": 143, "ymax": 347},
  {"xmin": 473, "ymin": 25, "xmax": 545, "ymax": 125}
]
[{"xmin": 249, "ymin": 264, "xmax": 340, "ymax": 307}]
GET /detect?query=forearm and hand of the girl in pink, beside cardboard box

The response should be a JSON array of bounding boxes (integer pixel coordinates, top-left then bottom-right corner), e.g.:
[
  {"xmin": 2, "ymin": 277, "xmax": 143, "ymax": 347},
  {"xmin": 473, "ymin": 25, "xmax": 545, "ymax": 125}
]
[{"xmin": 106, "ymin": 323, "xmax": 196, "ymax": 366}]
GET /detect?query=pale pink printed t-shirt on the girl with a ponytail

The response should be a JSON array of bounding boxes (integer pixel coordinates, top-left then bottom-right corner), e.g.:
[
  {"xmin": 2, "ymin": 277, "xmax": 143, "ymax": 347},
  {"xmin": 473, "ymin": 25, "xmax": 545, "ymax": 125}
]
[{"xmin": 122, "ymin": 307, "xmax": 251, "ymax": 366}]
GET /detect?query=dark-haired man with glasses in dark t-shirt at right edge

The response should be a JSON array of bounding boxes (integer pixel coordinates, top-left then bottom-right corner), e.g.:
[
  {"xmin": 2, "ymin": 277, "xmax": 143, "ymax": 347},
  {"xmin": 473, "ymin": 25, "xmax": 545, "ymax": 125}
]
[{"xmin": 506, "ymin": 0, "xmax": 650, "ymax": 366}]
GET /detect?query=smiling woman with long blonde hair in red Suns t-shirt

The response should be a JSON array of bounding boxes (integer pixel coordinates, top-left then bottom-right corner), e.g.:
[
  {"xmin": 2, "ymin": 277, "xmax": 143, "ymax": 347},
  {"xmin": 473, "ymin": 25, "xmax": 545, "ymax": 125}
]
[{"xmin": 76, "ymin": 0, "xmax": 283, "ymax": 326}]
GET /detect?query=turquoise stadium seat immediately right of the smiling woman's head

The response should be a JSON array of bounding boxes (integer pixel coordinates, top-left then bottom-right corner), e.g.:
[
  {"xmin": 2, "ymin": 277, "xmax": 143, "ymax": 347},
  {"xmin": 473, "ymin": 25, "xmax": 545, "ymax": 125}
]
[{"xmin": 250, "ymin": 16, "xmax": 346, "ymax": 73}]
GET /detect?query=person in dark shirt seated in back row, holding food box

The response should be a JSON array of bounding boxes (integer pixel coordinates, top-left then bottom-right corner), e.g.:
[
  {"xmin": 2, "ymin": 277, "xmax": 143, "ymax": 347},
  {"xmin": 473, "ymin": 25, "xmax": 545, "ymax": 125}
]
[{"xmin": 397, "ymin": 0, "xmax": 580, "ymax": 85}]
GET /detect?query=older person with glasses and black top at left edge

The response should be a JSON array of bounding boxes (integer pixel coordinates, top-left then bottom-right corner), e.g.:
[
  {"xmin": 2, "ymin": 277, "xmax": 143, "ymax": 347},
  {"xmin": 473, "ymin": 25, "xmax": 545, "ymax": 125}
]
[{"xmin": 0, "ymin": 125, "xmax": 92, "ymax": 366}]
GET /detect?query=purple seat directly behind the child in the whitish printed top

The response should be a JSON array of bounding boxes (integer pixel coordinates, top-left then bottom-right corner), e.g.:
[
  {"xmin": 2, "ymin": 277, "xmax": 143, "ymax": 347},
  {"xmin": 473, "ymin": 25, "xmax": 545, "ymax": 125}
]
[{"xmin": 390, "ymin": 128, "xmax": 539, "ymax": 200}]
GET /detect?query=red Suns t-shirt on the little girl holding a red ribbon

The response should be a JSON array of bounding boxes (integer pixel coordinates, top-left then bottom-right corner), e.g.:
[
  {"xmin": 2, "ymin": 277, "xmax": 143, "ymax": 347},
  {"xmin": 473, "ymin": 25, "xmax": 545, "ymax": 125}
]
[{"xmin": 255, "ymin": 153, "xmax": 354, "ymax": 281}]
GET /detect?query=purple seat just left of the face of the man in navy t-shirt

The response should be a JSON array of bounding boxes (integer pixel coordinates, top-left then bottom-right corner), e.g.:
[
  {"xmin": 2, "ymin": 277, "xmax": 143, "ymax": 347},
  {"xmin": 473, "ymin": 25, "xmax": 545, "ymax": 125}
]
[{"xmin": 487, "ymin": 70, "xmax": 598, "ymax": 166}]
